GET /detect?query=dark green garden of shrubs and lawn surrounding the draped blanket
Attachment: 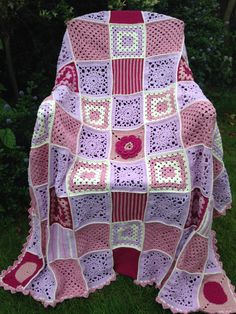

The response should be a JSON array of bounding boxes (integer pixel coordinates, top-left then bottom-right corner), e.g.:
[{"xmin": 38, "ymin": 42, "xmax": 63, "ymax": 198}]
[{"xmin": 0, "ymin": 0, "xmax": 236, "ymax": 314}]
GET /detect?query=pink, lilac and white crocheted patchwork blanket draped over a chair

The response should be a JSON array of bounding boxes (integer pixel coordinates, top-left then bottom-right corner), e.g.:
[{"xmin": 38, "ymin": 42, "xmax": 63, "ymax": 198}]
[{"xmin": 0, "ymin": 10, "xmax": 236, "ymax": 313}]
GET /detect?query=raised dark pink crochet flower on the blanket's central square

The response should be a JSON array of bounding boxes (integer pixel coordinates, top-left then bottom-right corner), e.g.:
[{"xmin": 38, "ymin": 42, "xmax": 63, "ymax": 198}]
[{"xmin": 116, "ymin": 135, "xmax": 142, "ymax": 159}]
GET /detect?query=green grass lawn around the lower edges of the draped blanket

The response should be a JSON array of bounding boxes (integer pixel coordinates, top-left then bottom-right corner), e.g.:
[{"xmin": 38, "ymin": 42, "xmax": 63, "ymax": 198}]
[{"xmin": 0, "ymin": 90, "xmax": 236, "ymax": 314}]
